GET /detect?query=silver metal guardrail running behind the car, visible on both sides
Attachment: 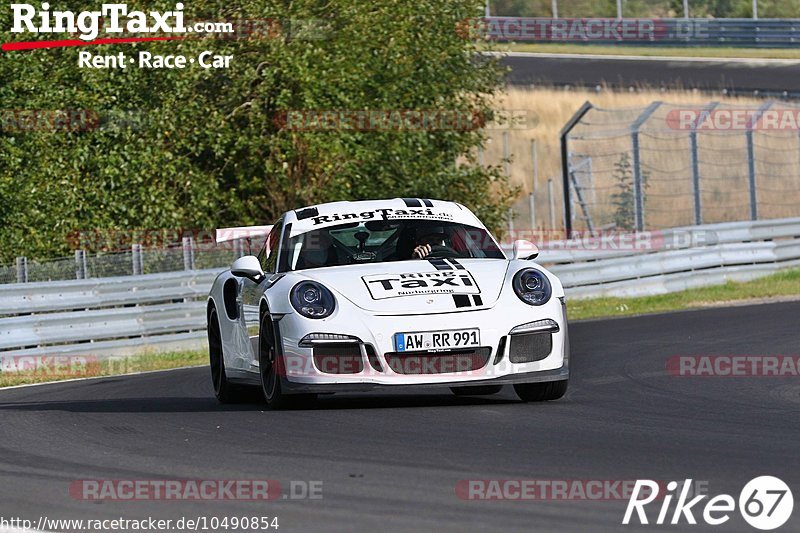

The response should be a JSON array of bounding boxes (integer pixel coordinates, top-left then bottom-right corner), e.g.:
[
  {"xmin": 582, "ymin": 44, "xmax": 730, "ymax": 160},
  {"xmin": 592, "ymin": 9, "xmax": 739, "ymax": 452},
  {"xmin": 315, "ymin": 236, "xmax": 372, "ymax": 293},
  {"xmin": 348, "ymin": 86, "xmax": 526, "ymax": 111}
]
[{"xmin": 0, "ymin": 218, "xmax": 800, "ymax": 358}]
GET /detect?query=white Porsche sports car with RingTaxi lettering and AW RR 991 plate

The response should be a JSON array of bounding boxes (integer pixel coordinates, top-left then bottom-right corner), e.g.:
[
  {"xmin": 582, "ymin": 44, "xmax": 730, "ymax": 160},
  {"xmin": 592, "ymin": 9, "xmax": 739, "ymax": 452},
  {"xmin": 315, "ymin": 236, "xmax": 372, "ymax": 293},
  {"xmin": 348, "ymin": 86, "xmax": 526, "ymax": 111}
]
[{"xmin": 208, "ymin": 198, "xmax": 569, "ymax": 408}]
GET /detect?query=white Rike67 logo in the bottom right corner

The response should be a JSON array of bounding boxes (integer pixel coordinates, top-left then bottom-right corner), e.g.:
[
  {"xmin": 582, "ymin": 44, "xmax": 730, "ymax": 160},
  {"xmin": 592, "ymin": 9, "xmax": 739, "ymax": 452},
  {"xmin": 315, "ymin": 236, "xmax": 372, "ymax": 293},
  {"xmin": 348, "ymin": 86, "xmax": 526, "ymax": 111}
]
[{"xmin": 622, "ymin": 476, "xmax": 794, "ymax": 531}]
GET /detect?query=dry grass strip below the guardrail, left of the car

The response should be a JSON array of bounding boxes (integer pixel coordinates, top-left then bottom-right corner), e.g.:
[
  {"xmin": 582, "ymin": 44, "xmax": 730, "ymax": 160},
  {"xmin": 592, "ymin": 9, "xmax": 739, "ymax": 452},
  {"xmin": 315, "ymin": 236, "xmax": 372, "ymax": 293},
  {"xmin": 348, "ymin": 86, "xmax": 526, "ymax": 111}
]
[{"xmin": 0, "ymin": 350, "xmax": 208, "ymax": 388}]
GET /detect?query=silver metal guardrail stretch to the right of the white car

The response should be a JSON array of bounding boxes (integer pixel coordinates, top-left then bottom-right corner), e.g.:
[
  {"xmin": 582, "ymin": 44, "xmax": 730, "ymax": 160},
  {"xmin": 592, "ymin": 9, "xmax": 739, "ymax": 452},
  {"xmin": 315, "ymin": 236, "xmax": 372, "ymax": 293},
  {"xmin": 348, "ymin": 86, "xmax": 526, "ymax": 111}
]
[{"xmin": 538, "ymin": 218, "xmax": 800, "ymax": 298}]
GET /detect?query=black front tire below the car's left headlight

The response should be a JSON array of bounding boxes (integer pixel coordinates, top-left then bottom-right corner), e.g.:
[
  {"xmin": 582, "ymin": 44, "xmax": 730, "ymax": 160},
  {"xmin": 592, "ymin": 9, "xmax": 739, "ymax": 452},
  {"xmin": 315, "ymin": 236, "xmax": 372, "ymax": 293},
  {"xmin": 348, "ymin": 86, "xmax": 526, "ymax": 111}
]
[{"xmin": 258, "ymin": 313, "xmax": 317, "ymax": 410}]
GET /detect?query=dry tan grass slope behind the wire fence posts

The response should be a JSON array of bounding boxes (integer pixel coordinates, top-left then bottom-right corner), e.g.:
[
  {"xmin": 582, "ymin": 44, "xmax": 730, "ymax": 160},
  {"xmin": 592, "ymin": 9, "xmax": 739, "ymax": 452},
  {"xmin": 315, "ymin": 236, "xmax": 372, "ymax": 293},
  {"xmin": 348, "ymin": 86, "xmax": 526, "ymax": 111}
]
[{"xmin": 484, "ymin": 88, "xmax": 800, "ymax": 228}]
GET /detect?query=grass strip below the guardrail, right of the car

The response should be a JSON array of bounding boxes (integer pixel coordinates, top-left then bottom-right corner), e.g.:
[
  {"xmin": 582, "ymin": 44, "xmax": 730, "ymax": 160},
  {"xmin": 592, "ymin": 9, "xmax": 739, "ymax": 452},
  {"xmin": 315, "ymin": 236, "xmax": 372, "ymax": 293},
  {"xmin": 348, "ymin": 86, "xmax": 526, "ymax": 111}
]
[{"xmin": 567, "ymin": 269, "xmax": 800, "ymax": 320}]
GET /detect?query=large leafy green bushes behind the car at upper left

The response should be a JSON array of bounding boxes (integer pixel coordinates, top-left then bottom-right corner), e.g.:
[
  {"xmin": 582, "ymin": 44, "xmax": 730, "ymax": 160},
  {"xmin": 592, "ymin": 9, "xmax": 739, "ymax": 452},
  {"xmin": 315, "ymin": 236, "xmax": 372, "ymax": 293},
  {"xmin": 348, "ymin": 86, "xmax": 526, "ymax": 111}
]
[{"xmin": 0, "ymin": 0, "xmax": 515, "ymax": 263}]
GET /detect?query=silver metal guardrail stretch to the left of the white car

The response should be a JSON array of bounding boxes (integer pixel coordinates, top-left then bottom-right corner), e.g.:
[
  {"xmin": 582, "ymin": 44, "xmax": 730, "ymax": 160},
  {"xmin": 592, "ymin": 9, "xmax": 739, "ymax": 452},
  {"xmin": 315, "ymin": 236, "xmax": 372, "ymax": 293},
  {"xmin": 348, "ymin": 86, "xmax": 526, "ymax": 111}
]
[{"xmin": 0, "ymin": 269, "xmax": 221, "ymax": 357}]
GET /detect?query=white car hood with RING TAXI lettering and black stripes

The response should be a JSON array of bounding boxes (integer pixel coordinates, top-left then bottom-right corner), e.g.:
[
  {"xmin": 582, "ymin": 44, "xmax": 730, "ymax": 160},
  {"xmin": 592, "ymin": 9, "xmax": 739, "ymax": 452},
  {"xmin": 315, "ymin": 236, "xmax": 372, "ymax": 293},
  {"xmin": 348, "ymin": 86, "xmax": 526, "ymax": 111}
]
[{"xmin": 296, "ymin": 259, "xmax": 509, "ymax": 315}]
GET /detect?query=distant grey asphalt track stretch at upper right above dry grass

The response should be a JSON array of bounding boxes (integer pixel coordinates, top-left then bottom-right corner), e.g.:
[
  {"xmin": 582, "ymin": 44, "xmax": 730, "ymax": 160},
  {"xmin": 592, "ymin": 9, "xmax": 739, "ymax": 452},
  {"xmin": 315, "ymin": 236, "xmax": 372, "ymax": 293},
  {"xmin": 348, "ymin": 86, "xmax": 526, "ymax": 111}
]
[{"xmin": 502, "ymin": 49, "xmax": 800, "ymax": 97}]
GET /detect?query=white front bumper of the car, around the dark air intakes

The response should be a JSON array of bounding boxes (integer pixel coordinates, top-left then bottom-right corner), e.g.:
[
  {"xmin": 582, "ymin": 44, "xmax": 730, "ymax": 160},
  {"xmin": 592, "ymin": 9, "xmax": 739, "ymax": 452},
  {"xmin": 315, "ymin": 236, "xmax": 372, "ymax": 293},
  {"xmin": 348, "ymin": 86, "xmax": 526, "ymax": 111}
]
[{"xmin": 279, "ymin": 297, "xmax": 569, "ymax": 393}]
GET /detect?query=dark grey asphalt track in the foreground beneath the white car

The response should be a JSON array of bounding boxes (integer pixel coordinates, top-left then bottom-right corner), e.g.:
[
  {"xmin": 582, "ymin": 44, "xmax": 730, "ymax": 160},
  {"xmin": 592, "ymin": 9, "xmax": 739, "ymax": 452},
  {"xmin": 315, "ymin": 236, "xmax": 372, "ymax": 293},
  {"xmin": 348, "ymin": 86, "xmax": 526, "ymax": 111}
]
[{"xmin": 0, "ymin": 302, "xmax": 800, "ymax": 532}]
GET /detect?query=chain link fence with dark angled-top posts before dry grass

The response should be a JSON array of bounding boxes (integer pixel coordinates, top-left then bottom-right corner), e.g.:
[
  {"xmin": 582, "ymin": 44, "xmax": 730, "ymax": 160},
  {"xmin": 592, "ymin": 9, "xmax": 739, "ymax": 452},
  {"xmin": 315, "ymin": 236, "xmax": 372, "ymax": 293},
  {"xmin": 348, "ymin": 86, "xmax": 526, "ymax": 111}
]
[{"xmin": 562, "ymin": 101, "xmax": 800, "ymax": 232}]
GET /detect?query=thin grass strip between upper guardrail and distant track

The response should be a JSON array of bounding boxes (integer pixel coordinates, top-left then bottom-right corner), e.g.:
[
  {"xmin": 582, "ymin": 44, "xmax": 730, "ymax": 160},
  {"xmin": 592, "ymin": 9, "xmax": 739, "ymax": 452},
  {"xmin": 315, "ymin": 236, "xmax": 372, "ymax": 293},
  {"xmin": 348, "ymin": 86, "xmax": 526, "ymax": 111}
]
[{"xmin": 496, "ymin": 43, "xmax": 800, "ymax": 59}]
